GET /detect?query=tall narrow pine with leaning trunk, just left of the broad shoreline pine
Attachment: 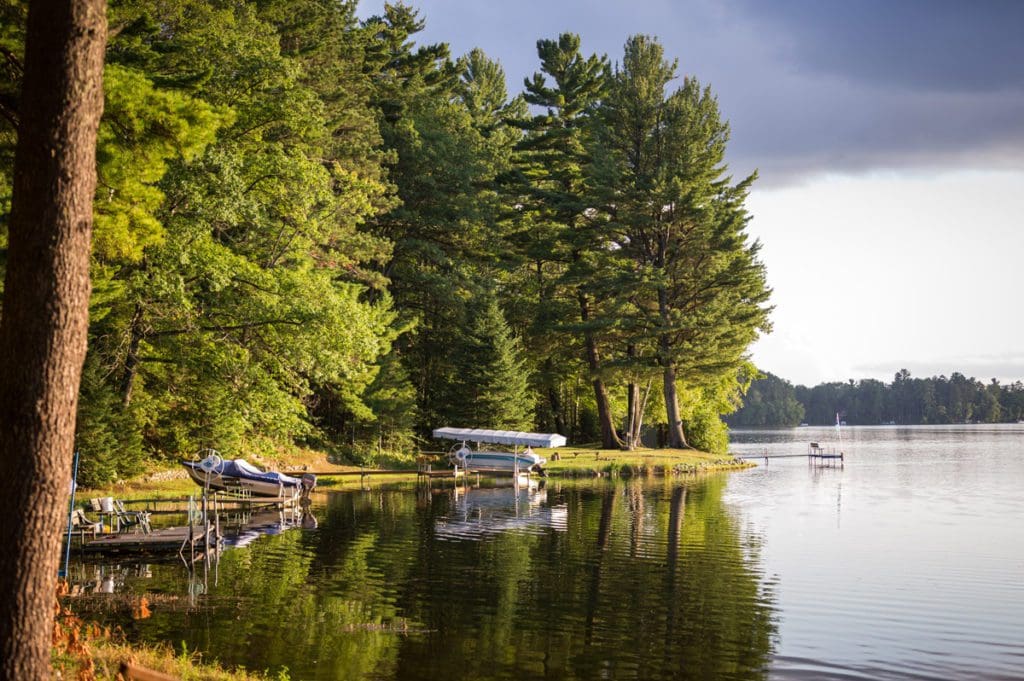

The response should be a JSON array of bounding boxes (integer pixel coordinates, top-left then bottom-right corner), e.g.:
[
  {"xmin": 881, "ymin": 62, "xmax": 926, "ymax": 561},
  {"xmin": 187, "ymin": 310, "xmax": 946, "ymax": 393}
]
[{"xmin": 513, "ymin": 33, "xmax": 622, "ymax": 449}]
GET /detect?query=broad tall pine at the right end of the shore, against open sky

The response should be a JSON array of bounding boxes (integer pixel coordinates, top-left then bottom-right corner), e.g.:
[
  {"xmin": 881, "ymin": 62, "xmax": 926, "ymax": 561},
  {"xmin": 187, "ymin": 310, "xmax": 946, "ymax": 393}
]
[{"xmin": 600, "ymin": 36, "xmax": 769, "ymax": 448}]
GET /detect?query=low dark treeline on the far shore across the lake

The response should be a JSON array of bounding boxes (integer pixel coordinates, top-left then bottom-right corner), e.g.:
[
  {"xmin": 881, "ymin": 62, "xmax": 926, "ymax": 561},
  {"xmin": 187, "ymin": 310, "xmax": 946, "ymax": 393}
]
[{"xmin": 726, "ymin": 369, "xmax": 1024, "ymax": 427}]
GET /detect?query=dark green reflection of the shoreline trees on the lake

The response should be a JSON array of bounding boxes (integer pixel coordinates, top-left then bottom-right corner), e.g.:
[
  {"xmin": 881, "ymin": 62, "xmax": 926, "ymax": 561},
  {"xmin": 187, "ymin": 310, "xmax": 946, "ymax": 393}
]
[{"xmin": 66, "ymin": 478, "xmax": 776, "ymax": 679}]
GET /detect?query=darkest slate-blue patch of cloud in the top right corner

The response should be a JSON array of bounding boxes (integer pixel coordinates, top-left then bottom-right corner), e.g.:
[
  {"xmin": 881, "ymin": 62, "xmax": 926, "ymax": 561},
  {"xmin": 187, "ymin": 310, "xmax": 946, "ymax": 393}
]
[{"xmin": 737, "ymin": 0, "xmax": 1024, "ymax": 92}]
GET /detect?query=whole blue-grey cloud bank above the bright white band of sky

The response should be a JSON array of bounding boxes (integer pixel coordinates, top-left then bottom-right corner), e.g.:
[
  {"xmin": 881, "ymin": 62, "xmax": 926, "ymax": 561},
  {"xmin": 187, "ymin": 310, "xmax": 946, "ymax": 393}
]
[{"xmin": 360, "ymin": 0, "xmax": 1024, "ymax": 185}]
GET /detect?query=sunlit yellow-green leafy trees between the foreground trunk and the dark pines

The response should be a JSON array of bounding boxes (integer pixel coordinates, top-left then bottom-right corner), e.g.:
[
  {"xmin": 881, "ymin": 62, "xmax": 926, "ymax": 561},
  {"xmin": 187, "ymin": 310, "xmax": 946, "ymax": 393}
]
[{"xmin": 79, "ymin": 2, "xmax": 397, "ymax": 474}]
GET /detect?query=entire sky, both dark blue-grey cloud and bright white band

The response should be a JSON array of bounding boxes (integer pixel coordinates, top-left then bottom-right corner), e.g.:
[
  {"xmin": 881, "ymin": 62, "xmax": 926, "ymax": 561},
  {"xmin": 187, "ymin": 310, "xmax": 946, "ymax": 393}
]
[{"xmin": 359, "ymin": 0, "xmax": 1024, "ymax": 385}]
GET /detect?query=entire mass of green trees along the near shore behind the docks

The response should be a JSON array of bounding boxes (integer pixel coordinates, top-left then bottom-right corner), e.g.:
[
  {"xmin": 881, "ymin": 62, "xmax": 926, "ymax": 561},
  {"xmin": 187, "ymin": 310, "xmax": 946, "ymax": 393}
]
[{"xmin": 0, "ymin": 0, "xmax": 778, "ymax": 477}]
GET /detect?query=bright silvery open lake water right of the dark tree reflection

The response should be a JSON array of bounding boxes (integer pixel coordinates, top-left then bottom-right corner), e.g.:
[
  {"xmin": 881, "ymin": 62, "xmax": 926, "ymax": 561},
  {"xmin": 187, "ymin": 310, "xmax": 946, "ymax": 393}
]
[{"xmin": 726, "ymin": 425, "xmax": 1024, "ymax": 679}]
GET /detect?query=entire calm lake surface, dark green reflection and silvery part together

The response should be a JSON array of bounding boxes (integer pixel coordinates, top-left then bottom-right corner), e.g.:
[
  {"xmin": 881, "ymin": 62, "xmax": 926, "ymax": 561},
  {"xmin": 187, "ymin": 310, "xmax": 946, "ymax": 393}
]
[{"xmin": 73, "ymin": 426, "xmax": 1024, "ymax": 680}]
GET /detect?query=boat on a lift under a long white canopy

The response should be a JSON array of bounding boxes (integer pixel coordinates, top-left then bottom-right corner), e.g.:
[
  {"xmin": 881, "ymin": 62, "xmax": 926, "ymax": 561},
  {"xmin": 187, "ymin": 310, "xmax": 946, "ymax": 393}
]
[{"xmin": 433, "ymin": 427, "xmax": 565, "ymax": 473}]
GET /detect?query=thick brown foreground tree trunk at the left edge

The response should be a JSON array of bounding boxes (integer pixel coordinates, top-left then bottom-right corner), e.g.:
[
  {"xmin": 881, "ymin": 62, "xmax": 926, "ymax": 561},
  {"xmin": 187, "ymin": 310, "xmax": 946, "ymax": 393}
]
[{"xmin": 0, "ymin": 0, "xmax": 106, "ymax": 681}]
